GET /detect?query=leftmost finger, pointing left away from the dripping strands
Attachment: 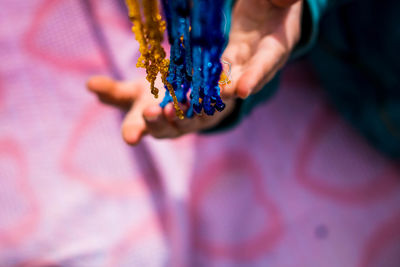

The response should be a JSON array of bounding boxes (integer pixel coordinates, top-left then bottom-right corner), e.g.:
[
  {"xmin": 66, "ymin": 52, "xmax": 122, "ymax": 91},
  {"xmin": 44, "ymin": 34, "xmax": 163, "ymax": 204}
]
[{"xmin": 87, "ymin": 76, "xmax": 140, "ymax": 109}]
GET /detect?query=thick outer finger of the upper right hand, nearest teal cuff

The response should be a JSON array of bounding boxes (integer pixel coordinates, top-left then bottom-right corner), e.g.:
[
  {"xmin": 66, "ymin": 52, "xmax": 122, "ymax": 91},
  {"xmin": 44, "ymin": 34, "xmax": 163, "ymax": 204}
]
[{"xmin": 235, "ymin": 38, "xmax": 287, "ymax": 99}]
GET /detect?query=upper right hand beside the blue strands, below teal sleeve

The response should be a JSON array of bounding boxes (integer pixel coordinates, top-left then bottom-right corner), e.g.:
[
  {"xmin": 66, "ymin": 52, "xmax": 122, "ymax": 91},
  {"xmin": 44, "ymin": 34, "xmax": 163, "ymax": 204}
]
[{"xmin": 222, "ymin": 0, "xmax": 302, "ymax": 98}]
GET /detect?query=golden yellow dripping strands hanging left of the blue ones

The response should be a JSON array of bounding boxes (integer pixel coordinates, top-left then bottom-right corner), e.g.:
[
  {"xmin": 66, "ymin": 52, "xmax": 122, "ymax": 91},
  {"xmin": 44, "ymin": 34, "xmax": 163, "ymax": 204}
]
[{"xmin": 126, "ymin": 0, "xmax": 184, "ymax": 119}]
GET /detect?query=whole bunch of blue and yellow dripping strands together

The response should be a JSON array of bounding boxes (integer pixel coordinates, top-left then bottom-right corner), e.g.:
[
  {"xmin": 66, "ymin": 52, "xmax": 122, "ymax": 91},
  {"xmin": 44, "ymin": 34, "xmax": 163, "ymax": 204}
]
[{"xmin": 126, "ymin": 0, "xmax": 232, "ymax": 119}]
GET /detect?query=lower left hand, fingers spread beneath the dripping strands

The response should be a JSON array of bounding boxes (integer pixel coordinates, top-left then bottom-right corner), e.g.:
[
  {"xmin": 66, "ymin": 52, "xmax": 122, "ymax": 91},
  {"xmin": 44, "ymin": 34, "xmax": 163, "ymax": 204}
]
[{"xmin": 87, "ymin": 77, "xmax": 234, "ymax": 145}]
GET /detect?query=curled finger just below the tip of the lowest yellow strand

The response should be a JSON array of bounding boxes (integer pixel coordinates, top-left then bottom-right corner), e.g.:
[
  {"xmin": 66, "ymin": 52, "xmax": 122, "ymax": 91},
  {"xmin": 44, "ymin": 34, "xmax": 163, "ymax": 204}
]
[{"xmin": 143, "ymin": 106, "xmax": 180, "ymax": 138}]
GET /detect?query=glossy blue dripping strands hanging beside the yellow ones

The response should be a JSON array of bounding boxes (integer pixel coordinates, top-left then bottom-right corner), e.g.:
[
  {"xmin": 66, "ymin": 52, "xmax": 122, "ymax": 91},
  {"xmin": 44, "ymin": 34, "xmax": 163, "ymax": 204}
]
[{"xmin": 160, "ymin": 0, "xmax": 233, "ymax": 118}]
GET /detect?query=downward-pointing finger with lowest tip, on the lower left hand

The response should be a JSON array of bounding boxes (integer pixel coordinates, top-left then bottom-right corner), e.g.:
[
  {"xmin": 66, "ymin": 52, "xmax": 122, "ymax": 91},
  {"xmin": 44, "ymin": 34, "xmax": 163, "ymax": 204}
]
[{"xmin": 121, "ymin": 106, "xmax": 147, "ymax": 145}]
